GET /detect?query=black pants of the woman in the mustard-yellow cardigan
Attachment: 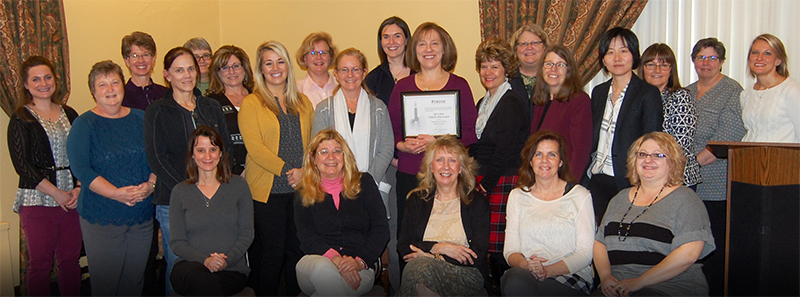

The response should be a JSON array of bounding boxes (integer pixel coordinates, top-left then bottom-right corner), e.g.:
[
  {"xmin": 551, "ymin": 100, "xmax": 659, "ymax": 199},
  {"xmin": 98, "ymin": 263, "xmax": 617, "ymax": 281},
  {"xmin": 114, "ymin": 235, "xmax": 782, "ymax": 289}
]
[{"xmin": 248, "ymin": 193, "xmax": 303, "ymax": 296}]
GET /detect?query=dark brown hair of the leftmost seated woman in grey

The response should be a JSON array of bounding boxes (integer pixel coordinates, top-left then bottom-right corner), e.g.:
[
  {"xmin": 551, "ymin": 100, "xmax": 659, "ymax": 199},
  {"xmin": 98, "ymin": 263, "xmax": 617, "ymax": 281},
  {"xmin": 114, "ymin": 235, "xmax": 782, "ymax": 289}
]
[{"xmin": 186, "ymin": 125, "xmax": 233, "ymax": 184}]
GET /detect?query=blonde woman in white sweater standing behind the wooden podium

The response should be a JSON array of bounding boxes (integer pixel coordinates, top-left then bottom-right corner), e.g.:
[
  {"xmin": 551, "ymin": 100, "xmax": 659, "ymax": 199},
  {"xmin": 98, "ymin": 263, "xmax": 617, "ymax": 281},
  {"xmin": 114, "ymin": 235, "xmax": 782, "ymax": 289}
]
[{"xmin": 739, "ymin": 34, "xmax": 800, "ymax": 143}]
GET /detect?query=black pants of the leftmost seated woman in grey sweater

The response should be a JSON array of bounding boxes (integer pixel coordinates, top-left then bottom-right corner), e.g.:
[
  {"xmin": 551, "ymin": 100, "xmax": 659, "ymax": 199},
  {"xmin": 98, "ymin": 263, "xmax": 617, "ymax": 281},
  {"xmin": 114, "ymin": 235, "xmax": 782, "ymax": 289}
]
[{"xmin": 169, "ymin": 261, "xmax": 247, "ymax": 296}]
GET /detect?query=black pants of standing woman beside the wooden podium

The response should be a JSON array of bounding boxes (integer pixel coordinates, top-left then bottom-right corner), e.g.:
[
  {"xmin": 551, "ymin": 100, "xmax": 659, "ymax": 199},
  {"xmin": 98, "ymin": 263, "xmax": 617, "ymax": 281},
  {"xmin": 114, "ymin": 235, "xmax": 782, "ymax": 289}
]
[{"xmin": 703, "ymin": 200, "xmax": 728, "ymax": 296}]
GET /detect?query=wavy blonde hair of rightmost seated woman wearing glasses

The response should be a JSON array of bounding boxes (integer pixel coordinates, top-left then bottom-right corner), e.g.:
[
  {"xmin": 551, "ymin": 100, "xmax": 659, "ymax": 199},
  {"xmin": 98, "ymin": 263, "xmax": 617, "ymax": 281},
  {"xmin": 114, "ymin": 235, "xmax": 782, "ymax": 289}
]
[{"xmin": 627, "ymin": 132, "xmax": 686, "ymax": 186}]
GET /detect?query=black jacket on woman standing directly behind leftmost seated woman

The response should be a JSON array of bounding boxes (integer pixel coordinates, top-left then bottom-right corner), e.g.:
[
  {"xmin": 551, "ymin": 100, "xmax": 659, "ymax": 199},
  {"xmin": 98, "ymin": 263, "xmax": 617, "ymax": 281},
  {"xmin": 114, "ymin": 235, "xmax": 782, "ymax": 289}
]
[{"xmin": 144, "ymin": 88, "xmax": 233, "ymax": 205}]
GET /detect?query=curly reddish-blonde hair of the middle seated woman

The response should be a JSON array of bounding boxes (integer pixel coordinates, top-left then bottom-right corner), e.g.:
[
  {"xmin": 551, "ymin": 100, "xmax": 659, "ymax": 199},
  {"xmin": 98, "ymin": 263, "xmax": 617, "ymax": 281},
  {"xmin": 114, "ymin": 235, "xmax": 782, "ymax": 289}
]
[{"xmin": 406, "ymin": 135, "xmax": 478, "ymax": 204}]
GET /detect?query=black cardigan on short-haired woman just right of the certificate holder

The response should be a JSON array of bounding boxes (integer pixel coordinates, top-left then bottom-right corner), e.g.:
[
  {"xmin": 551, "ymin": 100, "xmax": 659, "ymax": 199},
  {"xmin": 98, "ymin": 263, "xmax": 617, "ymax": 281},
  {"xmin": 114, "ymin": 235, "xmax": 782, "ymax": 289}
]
[{"xmin": 469, "ymin": 90, "xmax": 530, "ymax": 192}]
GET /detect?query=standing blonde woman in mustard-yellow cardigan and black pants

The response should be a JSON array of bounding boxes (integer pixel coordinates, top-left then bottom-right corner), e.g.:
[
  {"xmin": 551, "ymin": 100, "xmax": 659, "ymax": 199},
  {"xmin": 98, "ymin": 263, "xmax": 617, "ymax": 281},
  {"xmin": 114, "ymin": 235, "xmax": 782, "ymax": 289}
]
[{"xmin": 239, "ymin": 41, "xmax": 314, "ymax": 296}]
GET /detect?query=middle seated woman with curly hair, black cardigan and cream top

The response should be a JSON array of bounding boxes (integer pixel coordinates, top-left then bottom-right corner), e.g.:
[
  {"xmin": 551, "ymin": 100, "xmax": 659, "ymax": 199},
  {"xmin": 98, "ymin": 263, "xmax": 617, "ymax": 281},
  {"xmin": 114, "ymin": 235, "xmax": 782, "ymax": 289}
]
[{"xmin": 397, "ymin": 136, "xmax": 489, "ymax": 296}]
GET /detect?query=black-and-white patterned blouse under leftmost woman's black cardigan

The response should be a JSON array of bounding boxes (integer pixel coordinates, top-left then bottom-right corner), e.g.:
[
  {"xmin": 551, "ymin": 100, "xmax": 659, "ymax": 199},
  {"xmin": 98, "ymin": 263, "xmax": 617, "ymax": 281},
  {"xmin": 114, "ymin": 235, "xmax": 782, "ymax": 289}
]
[{"xmin": 13, "ymin": 106, "xmax": 73, "ymax": 212}]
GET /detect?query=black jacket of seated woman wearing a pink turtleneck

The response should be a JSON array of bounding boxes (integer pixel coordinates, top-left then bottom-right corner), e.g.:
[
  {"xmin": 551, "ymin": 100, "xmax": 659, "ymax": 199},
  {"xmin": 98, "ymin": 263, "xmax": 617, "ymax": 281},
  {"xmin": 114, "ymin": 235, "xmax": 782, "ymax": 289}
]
[{"xmin": 294, "ymin": 173, "xmax": 389, "ymax": 268}]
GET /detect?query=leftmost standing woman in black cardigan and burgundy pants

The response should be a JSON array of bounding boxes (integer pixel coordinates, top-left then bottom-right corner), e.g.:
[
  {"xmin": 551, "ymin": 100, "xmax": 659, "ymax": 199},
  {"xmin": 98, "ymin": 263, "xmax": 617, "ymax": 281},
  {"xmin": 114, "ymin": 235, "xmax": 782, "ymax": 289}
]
[{"xmin": 8, "ymin": 56, "xmax": 82, "ymax": 296}]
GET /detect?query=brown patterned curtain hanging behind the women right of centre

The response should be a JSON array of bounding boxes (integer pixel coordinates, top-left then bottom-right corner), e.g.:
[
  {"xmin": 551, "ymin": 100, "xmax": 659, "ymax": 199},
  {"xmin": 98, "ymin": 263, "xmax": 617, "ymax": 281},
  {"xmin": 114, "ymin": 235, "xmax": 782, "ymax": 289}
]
[{"xmin": 479, "ymin": 0, "xmax": 647, "ymax": 84}]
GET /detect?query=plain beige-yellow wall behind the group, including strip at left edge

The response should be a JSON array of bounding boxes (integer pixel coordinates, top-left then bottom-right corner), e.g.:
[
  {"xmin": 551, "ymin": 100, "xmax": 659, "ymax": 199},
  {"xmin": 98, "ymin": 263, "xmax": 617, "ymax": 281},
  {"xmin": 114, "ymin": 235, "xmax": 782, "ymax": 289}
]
[{"xmin": 0, "ymin": 0, "xmax": 484, "ymax": 285}]
